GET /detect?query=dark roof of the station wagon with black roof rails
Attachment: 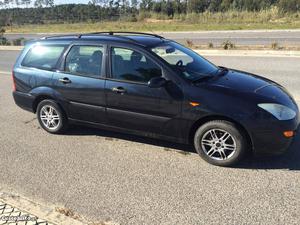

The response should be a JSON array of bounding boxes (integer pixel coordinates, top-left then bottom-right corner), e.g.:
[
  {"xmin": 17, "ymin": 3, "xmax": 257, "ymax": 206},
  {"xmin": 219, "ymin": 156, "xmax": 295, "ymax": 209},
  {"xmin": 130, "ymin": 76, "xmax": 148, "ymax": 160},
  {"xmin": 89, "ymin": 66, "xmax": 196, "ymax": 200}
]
[{"xmin": 40, "ymin": 32, "xmax": 169, "ymax": 47}]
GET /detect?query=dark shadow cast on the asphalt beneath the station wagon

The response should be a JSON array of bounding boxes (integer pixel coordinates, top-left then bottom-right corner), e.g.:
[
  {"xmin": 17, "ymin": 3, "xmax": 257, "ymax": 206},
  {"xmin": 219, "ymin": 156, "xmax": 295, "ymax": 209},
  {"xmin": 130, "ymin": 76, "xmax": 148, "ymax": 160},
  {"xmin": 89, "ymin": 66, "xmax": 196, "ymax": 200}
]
[{"xmin": 67, "ymin": 126, "xmax": 300, "ymax": 171}]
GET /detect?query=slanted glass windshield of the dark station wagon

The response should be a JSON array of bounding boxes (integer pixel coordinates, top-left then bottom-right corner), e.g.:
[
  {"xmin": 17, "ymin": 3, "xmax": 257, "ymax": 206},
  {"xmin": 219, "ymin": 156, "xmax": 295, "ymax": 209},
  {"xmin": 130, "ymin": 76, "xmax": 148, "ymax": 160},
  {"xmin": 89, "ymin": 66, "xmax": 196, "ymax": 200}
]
[{"xmin": 151, "ymin": 42, "xmax": 219, "ymax": 81}]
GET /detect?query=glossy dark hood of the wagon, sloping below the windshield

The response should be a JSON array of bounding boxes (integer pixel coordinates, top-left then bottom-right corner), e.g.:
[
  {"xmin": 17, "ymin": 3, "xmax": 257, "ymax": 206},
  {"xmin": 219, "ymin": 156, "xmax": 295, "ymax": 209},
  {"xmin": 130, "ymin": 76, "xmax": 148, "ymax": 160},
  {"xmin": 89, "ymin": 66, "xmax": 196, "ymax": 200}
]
[{"xmin": 207, "ymin": 70, "xmax": 280, "ymax": 93}]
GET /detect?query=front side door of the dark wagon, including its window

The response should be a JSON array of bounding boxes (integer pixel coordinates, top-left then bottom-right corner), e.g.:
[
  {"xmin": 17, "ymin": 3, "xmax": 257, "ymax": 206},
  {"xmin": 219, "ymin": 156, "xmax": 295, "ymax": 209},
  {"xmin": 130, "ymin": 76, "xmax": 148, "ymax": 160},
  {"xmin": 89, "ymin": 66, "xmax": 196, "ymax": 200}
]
[{"xmin": 105, "ymin": 46, "xmax": 181, "ymax": 133}]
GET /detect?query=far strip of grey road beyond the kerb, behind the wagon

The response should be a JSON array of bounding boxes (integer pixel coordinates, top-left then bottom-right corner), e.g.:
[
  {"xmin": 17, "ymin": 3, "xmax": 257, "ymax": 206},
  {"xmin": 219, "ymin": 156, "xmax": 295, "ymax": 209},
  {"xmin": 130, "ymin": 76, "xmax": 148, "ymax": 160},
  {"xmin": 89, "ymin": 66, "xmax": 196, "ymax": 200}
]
[{"xmin": 6, "ymin": 30, "xmax": 300, "ymax": 46}]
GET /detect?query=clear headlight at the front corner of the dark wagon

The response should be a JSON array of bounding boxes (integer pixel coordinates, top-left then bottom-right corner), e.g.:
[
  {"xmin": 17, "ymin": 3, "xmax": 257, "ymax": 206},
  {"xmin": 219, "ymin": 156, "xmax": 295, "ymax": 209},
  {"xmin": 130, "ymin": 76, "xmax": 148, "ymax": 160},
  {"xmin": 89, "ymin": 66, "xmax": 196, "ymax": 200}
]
[{"xmin": 258, "ymin": 103, "xmax": 296, "ymax": 120}]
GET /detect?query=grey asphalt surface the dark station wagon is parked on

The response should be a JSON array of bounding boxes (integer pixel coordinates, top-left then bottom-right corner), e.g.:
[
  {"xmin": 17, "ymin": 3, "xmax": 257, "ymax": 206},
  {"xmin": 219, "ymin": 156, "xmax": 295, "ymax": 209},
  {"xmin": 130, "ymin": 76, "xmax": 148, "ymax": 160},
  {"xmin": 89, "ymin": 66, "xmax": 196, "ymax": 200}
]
[{"xmin": 0, "ymin": 52, "xmax": 300, "ymax": 225}]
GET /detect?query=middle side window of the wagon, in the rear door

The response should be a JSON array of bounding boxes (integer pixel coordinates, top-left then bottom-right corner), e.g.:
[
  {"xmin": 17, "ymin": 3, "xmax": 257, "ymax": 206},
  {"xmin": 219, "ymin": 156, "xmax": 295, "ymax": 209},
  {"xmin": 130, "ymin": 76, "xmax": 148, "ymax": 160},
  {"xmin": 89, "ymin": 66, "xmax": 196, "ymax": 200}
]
[{"xmin": 65, "ymin": 46, "xmax": 103, "ymax": 77}]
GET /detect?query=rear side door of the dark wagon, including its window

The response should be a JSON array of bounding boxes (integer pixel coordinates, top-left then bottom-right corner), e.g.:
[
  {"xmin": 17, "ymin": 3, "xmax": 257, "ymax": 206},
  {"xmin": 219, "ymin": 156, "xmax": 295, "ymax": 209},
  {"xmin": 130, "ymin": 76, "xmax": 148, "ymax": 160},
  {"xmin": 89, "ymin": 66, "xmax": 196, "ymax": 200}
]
[{"xmin": 53, "ymin": 44, "xmax": 106, "ymax": 123}]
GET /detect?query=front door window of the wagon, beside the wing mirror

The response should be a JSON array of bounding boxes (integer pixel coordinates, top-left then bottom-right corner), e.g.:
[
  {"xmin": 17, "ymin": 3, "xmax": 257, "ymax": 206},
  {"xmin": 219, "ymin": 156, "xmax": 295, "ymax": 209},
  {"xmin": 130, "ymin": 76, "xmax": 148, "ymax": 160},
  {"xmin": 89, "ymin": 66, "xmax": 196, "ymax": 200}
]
[{"xmin": 111, "ymin": 48, "xmax": 162, "ymax": 83}]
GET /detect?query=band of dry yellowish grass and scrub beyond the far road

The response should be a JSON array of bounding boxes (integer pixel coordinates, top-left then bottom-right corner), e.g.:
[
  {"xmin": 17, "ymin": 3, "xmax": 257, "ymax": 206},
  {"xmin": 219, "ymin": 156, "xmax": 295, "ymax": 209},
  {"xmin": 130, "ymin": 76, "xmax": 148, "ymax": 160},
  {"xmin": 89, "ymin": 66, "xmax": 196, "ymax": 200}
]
[{"xmin": 6, "ymin": 7, "xmax": 300, "ymax": 33}]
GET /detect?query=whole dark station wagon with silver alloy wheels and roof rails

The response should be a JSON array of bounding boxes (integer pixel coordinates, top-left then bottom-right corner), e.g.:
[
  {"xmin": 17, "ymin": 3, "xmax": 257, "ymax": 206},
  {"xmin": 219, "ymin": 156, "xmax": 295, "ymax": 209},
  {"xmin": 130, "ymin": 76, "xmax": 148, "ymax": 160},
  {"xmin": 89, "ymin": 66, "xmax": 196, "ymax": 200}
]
[{"xmin": 13, "ymin": 32, "xmax": 299, "ymax": 166}]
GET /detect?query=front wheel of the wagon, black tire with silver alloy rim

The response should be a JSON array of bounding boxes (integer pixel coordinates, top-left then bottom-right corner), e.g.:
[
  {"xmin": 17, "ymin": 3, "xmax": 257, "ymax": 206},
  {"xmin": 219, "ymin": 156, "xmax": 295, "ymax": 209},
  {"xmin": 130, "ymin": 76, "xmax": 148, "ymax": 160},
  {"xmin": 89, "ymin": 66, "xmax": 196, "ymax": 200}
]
[{"xmin": 194, "ymin": 120, "xmax": 248, "ymax": 167}]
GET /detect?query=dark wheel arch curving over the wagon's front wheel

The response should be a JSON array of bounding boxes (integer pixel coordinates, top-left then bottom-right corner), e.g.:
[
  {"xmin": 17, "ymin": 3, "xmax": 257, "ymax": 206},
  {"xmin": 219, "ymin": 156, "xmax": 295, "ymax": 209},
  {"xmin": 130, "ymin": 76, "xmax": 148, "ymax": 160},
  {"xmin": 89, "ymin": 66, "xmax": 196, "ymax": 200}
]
[{"xmin": 188, "ymin": 115, "xmax": 253, "ymax": 150}]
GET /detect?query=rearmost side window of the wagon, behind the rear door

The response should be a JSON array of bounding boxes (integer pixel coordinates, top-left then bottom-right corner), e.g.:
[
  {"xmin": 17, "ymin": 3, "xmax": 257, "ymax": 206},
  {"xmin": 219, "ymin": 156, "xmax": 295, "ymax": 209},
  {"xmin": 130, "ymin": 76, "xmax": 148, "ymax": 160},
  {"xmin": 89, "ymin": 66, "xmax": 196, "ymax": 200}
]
[{"xmin": 22, "ymin": 45, "xmax": 66, "ymax": 70}]
